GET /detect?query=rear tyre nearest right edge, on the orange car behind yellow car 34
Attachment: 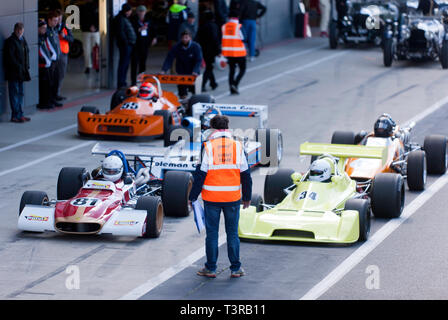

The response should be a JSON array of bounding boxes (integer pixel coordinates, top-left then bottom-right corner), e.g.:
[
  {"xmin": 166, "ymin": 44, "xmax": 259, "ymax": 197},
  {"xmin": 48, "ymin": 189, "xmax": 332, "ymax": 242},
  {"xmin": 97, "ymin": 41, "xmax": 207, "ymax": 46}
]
[{"xmin": 423, "ymin": 135, "xmax": 448, "ymax": 174}]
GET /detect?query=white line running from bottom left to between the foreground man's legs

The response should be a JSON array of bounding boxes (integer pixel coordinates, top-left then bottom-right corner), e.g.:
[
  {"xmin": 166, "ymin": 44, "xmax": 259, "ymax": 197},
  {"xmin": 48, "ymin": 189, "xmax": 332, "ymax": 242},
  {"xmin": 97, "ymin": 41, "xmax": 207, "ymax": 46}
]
[{"xmin": 119, "ymin": 235, "xmax": 226, "ymax": 300}]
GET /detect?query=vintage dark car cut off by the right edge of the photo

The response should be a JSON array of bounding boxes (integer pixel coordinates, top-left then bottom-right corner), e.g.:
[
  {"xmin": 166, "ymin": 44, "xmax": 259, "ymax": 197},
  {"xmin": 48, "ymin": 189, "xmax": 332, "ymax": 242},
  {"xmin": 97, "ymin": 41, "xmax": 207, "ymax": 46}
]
[{"xmin": 383, "ymin": 8, "xmax": 448, "ymax": 69}]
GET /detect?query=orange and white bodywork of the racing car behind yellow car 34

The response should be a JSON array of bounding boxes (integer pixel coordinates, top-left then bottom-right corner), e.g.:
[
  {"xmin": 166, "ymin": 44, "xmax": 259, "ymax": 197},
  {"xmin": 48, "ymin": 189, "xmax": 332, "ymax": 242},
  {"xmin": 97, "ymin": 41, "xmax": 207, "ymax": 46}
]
[{"xmin": 345, "ymin": 133, "xmax": 404, "ymax": 180}]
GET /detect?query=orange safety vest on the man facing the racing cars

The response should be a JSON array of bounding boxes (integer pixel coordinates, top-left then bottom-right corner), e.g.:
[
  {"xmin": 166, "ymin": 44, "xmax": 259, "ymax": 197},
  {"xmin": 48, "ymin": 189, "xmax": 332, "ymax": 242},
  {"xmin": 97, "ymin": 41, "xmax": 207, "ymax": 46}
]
[{"xmin": 202, "ymin": 137, "xmax": 242, "ymax": 202}]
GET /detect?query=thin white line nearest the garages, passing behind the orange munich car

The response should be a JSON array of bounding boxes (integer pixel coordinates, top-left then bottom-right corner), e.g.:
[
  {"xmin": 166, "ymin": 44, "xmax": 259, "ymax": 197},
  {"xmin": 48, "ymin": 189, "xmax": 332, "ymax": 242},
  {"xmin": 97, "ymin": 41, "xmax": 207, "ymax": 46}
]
[{"xmin": 0, "ymin": 45, "xmax": 328, "ymax": 152}]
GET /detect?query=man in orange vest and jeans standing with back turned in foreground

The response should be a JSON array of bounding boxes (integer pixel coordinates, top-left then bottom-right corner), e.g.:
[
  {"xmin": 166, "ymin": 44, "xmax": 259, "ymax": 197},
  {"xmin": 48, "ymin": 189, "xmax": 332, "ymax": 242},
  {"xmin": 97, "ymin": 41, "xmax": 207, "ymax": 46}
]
[{"xmin": 189, "ymin": 115, "xmax": 252, "ymax": 278}]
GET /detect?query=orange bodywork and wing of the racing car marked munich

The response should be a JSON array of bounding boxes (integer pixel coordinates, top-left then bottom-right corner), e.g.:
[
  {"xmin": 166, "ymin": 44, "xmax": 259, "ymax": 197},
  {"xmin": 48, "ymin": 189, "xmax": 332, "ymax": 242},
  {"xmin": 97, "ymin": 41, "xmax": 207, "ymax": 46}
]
[{"xmin": 78, "ymin": 74, "xmax": 196, "ymax": 138}]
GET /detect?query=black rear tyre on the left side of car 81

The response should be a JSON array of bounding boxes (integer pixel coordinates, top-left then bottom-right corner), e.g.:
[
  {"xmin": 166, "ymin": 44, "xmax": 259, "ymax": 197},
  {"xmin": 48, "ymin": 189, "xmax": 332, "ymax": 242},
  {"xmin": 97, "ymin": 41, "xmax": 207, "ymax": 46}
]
[{"xmin": 57, "ymin": 167, "xmax": 90, "ymax": 200}]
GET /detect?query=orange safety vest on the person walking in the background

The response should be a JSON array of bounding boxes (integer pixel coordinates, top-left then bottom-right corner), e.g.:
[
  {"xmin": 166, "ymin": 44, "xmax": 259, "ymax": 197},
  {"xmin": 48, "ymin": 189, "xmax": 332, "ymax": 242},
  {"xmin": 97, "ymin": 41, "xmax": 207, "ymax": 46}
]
[{"xmin": 221, "ymin": 19, "xmax": 246, "ymax": 57}]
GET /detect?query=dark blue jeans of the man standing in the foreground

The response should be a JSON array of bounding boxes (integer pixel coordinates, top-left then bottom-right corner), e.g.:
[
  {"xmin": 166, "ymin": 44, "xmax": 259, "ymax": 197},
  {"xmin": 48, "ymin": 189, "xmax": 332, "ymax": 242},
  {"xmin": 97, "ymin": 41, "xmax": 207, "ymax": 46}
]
[{"xmin": 204, "ymin": 202, "xmax": 241, "ymax": 271}]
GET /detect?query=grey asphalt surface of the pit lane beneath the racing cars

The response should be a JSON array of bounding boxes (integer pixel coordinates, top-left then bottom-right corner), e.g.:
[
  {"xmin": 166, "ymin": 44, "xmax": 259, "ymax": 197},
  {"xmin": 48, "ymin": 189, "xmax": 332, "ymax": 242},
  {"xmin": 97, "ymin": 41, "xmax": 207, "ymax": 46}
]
[{"xmin": 0, "ymin": 38, "xmax": 448, "ymax": 299}]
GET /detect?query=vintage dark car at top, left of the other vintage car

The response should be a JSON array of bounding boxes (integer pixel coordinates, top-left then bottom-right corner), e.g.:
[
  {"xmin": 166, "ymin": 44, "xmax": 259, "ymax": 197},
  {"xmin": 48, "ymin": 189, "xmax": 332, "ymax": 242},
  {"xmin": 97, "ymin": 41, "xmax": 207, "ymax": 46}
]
[{"xmin": 329, "ymin": 0, "xmax": 399, "ymax": 49}]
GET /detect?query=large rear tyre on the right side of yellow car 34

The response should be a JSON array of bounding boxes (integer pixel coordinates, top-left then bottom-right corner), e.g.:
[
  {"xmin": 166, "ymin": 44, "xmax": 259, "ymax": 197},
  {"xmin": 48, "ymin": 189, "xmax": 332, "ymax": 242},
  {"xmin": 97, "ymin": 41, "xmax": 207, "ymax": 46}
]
[{"xmin": 370, "ymin": 173, "xmax": 404, "ymax": 219}]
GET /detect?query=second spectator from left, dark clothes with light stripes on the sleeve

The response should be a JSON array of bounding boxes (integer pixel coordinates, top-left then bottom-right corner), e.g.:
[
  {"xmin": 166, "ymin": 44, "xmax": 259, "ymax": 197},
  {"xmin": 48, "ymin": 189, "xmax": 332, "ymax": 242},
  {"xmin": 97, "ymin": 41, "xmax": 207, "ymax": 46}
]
[{"xmin": 37, "ymin": 19, "xmax": 57, "ymax": 109}]
